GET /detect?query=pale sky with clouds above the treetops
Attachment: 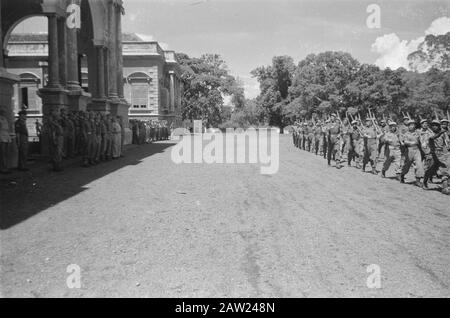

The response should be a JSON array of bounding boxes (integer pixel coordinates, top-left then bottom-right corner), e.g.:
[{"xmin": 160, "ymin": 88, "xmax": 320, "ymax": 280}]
[{"xmin": 11, "ymin": 0, "xmax": 450, "ymax": 98}]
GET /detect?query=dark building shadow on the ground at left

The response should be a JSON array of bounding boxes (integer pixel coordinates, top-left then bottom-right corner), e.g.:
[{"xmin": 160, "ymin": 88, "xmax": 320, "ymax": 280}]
[{"xmin": 0, "ymin": 142, "xmax": 174, "ymax": 230}]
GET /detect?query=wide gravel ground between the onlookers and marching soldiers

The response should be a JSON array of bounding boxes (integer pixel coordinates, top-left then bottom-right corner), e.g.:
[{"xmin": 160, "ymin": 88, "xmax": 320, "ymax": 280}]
[{"xmin": 0, "ymin": 136, "xmax": 450, "ymax": 297}]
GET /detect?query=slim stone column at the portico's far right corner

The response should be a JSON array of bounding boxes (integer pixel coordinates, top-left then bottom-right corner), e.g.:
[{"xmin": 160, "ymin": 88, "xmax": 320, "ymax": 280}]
[{"xmin": 108, "ymin": 2, "xmax": 118, "ymax": 99}]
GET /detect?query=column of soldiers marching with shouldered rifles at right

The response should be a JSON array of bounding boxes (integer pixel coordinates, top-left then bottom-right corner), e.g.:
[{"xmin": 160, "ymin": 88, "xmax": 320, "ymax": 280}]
[{"xmin": 293, "ymin": 111, "xmax": 450, "ymax": 194}]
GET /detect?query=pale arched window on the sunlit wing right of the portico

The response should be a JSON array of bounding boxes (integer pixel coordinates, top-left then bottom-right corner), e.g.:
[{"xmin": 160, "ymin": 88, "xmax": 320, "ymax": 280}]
[{"xmin": 126, "ymin": 72, "xmax": 152, "ymax": 109}]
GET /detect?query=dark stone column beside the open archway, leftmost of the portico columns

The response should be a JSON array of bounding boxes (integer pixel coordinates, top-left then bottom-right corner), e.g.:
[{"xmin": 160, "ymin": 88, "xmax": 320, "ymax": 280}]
[{"xmin": 47, "ymin": 14, "xmax": 61, "ymax": 88}]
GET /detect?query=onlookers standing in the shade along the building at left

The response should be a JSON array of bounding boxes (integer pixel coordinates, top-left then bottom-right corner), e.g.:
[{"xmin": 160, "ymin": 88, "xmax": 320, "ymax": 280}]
[{"xmin": 0, "ymin": 109, "xmax": 170, "ymax": 173}]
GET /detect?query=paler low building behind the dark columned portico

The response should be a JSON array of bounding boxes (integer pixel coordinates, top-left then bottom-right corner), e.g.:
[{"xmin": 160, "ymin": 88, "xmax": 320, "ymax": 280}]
[{"xmin": 6, "ymin": 34, "xmax": 182, "ymax": 135}]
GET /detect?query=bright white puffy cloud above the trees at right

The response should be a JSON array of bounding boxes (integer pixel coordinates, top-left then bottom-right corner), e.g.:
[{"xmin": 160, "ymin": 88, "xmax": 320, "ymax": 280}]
[{"xmin": 372, "ymin": 17, "xmax": 450, "ymax": 69}]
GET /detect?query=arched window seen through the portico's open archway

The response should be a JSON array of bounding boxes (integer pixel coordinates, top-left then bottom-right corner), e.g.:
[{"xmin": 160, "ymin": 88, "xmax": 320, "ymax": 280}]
[{"xmin": 19, "ymin": 73, "xmax": 42, "ymax": 112}]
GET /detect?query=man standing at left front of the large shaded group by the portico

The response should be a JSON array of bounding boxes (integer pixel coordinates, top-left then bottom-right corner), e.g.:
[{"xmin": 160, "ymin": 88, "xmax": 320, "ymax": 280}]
[{"xmin": 48, "ymin": 111, "xmax": 64, "ymax": 172}]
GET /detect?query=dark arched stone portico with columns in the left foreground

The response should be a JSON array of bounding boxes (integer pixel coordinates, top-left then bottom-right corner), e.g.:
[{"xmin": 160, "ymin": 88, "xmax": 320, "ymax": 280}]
[{"xmin": 0, "ymin": 0, "xmax": 131, "ymax": 147}]
